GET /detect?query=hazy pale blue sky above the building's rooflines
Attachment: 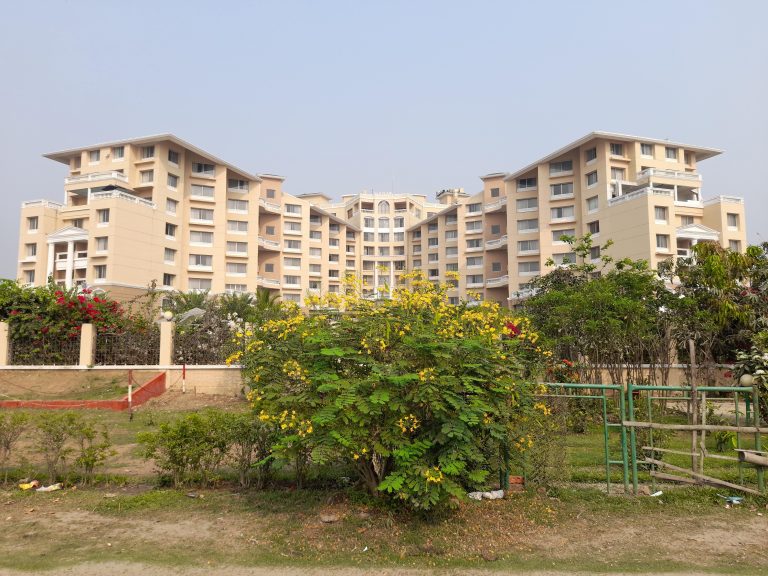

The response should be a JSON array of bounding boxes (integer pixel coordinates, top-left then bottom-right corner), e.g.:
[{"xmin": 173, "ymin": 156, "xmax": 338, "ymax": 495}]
[{"xmin": 0, "ymin": 0, "xmax": 768, "ymax": 277}]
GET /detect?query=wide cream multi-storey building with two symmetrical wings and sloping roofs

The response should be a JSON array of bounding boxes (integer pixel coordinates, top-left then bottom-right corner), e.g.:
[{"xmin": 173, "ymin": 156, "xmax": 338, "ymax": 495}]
[{"xmin": 19, "ymin": 132, "xmax": 746, "ymax": 302}]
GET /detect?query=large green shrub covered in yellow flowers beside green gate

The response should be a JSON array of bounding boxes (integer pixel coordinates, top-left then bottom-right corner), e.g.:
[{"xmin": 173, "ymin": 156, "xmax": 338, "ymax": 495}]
[{"xmin": 234, "ymin": 273, "xmax": 537, "ymax": 510}]
